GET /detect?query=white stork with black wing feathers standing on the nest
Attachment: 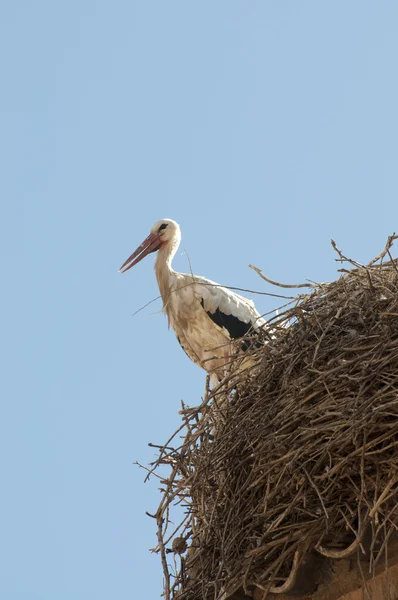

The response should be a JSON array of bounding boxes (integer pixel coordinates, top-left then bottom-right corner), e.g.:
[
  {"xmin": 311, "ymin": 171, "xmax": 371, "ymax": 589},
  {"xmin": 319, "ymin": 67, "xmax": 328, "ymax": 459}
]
[{"xmin": 119, "ymin": 219, "xmax": 266, "ymax": 382}]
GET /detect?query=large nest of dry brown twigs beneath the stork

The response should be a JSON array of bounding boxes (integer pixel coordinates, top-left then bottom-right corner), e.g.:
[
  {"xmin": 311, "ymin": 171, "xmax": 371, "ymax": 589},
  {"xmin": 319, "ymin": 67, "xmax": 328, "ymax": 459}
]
[{"xmin": 148, "ymin": 236, "xmax": 398, "ymax": 600}]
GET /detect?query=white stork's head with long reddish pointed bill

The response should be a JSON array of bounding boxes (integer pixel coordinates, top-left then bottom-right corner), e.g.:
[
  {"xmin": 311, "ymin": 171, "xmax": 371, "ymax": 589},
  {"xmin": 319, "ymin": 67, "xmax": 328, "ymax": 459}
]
[{"xmin": 119, "ymin": 219, "xmax": 181, "ymax": 273}]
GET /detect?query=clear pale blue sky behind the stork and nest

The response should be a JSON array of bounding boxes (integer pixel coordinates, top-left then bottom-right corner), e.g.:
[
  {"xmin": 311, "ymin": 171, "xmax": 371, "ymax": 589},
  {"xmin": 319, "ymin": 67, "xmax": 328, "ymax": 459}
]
[{"xmin": 0, "ymin": 0, "xmax": 398, "ymax": 600}]
